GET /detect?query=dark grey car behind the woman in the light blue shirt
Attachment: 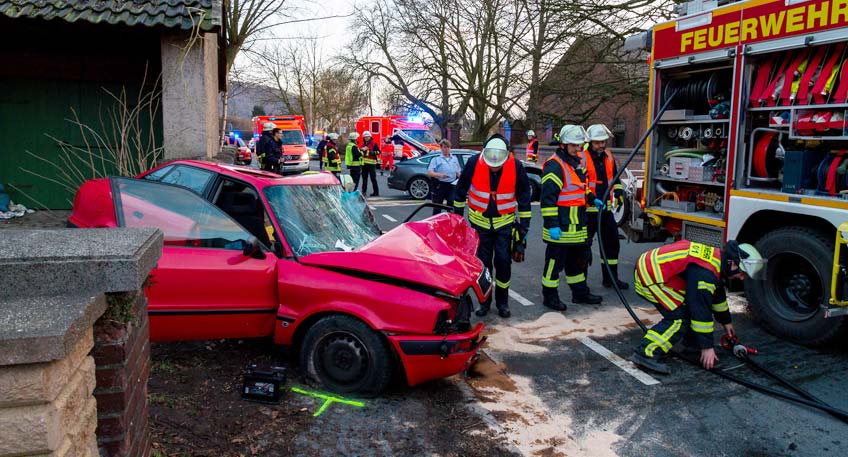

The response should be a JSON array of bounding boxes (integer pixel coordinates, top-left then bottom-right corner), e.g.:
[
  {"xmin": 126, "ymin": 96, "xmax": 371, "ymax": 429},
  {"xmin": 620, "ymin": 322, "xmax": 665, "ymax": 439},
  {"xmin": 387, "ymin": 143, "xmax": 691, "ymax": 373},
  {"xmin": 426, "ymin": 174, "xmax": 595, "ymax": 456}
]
[{"xmin": 388, "ymin": 149, "xmax": 542, "ymax": 200}]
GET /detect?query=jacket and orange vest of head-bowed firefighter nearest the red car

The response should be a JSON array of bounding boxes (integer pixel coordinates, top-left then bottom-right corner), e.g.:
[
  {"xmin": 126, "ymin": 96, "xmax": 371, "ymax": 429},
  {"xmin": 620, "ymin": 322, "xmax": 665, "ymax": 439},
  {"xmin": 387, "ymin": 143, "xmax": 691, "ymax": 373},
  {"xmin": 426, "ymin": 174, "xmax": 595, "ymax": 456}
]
[{"xmin": 453, "ymin": 154, "xmax": 532, "ymax": 231}]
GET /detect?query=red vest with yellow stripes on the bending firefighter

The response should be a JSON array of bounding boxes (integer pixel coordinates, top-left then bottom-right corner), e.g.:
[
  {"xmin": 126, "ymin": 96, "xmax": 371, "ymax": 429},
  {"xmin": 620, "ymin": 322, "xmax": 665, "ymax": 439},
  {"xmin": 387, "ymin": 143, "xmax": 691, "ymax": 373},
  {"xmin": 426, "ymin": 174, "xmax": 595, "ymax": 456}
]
[{"xmin": 636, "ymin": 240, "xmax": 721, "ymax": 311}]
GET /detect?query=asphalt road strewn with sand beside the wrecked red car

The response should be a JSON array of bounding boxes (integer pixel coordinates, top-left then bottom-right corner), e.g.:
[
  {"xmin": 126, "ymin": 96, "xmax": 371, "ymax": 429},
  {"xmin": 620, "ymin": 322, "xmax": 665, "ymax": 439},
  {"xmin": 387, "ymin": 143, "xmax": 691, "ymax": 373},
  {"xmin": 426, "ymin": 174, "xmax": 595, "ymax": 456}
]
[{"xmin": 334, "ymin": 160, "xmax": 848, "ymax": 456}]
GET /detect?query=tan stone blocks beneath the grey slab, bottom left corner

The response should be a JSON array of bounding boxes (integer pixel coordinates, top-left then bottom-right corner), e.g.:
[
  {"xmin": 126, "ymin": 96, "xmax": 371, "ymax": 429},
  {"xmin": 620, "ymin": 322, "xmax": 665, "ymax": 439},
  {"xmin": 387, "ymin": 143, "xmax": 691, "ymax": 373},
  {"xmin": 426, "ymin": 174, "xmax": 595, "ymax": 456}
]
[{"xmin": 0, "ymin": 328, "xmax": 97, "ymax": 456}]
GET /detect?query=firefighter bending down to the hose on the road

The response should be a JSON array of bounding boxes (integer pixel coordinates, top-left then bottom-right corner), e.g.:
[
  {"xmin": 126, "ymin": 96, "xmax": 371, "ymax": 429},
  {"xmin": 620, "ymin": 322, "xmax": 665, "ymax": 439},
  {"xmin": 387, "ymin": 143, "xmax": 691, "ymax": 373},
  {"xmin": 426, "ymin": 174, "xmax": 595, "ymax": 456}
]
[{"xmin": 630, "ymin": 240, "xmax": 765, "ymax": 374}]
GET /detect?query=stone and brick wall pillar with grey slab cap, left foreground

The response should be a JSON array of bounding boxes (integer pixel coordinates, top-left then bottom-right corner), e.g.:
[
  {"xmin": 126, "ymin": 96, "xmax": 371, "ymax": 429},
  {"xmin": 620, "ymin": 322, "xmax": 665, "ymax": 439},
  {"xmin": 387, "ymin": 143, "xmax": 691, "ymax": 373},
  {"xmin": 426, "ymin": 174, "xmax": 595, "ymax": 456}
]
[{"xmin": 0, "ymin": 229, "xmax": 162, "ymax": 456}]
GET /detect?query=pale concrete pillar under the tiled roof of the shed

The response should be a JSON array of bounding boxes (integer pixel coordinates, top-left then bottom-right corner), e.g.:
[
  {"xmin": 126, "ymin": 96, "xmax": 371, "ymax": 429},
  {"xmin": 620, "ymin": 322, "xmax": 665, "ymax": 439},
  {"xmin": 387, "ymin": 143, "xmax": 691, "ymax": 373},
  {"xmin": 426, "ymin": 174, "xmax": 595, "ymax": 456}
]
[{"xmin": 161, "ymin": 32, "xmax": 221, "ymax": 160}]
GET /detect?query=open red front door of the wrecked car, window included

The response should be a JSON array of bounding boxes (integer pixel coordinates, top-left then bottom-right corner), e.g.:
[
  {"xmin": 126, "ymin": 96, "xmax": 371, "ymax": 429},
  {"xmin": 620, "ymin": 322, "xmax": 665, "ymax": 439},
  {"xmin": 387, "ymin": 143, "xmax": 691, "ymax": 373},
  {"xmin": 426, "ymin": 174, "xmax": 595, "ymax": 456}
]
[{"xmin": 112, "ymin": 178, "xmax": 278, "ymax": 341}]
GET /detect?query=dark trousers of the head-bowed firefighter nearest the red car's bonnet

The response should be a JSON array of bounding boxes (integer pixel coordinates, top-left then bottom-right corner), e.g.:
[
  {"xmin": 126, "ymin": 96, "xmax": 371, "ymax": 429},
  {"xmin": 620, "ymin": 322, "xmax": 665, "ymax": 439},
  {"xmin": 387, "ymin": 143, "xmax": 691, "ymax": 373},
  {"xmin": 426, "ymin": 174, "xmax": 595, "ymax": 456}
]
[{"xmin": 477, "ymin": 225, "xmax": 512, "ymax": 310}]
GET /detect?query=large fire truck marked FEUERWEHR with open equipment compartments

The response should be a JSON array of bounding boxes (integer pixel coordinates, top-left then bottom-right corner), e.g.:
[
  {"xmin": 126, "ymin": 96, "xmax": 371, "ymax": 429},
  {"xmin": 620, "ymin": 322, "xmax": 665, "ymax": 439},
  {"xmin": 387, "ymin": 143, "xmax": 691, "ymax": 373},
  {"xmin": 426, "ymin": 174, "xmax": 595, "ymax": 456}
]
[{"xmin": 626, "ymin": 0, "xmax": 848, "ymax": 344}]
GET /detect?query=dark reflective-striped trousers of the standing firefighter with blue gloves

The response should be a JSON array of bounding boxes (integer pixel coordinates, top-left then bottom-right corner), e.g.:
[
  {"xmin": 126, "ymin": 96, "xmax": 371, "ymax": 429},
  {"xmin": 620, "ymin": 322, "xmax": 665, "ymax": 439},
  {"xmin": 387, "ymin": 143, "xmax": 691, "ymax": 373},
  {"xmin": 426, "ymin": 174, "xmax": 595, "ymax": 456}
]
[{"xmin": 542, "ymin": 243, "xmax": 589, "ymax": 302}]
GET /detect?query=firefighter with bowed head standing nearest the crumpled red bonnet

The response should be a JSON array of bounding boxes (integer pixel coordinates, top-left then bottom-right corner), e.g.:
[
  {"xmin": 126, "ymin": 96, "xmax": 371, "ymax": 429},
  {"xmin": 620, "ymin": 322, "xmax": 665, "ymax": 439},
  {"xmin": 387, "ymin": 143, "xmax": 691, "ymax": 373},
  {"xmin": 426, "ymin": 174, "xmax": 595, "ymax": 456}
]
[{"xmin": 453, "ymin": 134, "xmax": 532, "ymax": 318}]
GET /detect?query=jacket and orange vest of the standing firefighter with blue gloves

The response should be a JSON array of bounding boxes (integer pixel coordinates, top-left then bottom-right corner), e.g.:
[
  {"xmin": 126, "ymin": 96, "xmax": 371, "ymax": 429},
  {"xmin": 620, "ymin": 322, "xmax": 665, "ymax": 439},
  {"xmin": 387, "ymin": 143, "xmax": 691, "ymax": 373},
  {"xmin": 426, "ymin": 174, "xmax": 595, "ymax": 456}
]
[{"xmin": 541, "ymin": 149, "xmax": 594, "ymax": 244}]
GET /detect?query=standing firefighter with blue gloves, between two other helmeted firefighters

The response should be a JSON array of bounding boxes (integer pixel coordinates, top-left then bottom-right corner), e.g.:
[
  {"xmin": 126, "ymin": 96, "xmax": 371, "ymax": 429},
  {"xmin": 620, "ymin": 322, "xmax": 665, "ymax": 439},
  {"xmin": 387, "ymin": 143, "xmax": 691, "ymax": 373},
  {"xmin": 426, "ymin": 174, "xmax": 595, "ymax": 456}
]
[{"xmin": 541, "ymin": 125, "xmax": 602, "ymax": 311}]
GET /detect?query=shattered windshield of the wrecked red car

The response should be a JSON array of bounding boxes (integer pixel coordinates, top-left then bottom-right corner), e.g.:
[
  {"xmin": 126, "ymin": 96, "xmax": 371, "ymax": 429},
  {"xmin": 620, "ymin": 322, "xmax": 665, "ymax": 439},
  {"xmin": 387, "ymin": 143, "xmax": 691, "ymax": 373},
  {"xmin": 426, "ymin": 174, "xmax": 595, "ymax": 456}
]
[{"xmin": 264, "ymin": 185, "xmax": 380, "ymax": 257}]
